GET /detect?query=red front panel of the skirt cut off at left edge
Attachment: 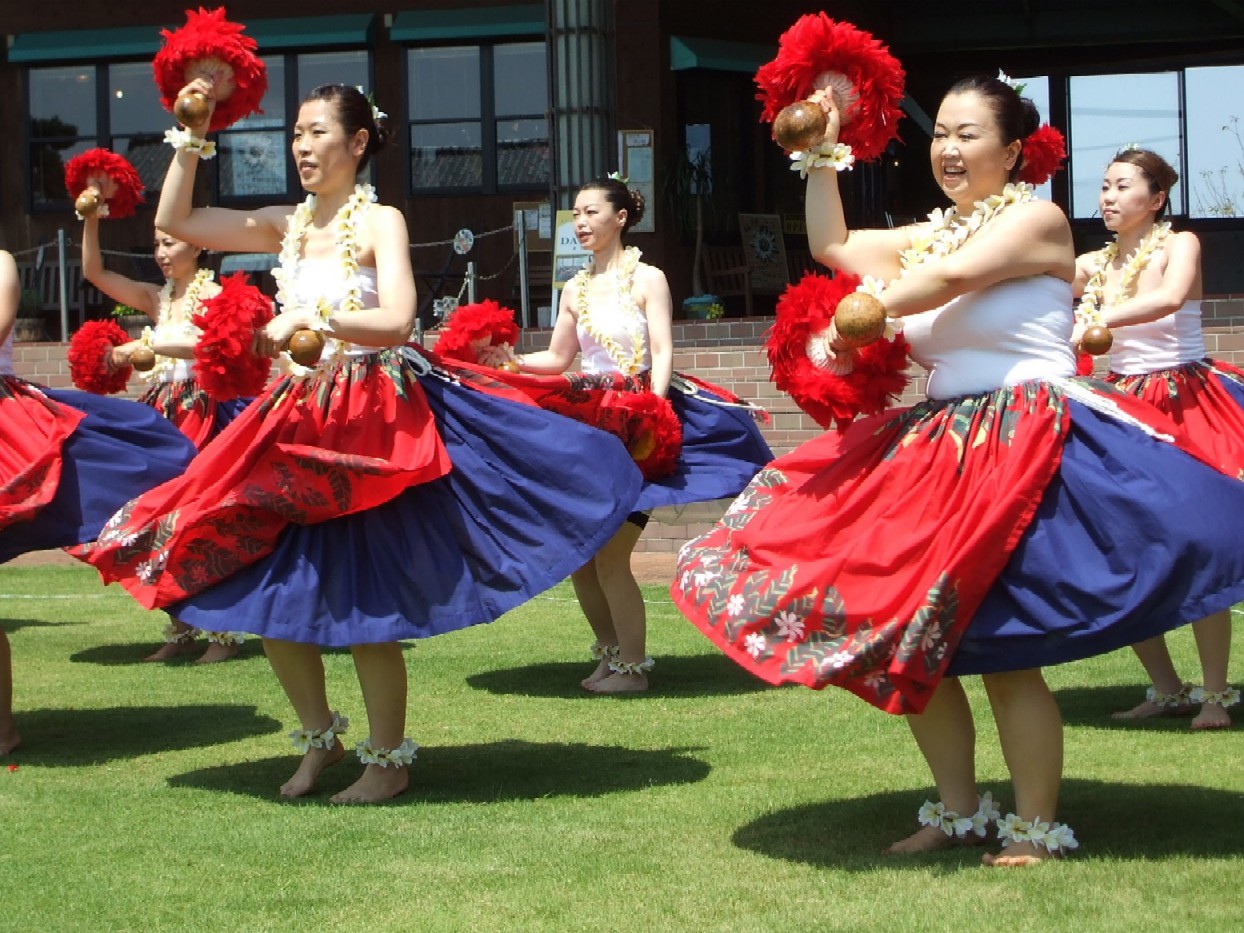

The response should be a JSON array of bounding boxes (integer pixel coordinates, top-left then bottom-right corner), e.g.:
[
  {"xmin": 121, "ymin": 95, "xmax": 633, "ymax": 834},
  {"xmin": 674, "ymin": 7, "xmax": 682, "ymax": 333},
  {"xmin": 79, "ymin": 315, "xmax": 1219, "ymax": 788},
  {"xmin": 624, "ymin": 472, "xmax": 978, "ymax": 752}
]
[{"xmin": 0, "ymin": 376, "xmax": 85, "ymax": 527}]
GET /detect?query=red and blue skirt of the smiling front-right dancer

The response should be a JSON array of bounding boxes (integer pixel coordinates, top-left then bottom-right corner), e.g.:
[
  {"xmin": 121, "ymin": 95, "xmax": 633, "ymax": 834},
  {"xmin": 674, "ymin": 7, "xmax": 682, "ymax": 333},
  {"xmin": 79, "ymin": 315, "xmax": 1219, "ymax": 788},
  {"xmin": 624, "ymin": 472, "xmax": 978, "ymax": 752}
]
[{"xmin": 671, "ymin": 381, "xmax": 1244, "ymax": 713}]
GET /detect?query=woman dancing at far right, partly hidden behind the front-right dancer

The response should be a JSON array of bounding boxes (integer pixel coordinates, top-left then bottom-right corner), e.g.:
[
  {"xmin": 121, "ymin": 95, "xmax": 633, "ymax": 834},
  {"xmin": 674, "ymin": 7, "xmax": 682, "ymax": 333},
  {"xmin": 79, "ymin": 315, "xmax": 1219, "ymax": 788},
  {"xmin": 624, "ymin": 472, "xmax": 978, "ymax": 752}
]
[{"xmin": 1074, "ymin": 148, "xmax": 1244, "ymax": 730}]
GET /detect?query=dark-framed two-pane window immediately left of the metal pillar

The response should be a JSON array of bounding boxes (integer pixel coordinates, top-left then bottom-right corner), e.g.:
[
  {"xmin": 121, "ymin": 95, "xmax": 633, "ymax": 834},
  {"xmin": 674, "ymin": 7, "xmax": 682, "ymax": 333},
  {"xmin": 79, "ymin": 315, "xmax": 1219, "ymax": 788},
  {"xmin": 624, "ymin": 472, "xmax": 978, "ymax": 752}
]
[{"xmin": 407, "ymin": 42, "xmax": 549, "ymax": 194}]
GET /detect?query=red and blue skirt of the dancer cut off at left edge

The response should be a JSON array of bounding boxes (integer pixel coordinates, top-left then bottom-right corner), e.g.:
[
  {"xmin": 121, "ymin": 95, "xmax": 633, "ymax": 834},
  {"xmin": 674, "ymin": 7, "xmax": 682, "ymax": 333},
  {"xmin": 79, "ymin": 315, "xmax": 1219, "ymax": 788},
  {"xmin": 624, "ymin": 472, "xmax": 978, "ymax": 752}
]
[{"xmin": 0, "ymin": 376, "xmax": 195, "ymax": 562}]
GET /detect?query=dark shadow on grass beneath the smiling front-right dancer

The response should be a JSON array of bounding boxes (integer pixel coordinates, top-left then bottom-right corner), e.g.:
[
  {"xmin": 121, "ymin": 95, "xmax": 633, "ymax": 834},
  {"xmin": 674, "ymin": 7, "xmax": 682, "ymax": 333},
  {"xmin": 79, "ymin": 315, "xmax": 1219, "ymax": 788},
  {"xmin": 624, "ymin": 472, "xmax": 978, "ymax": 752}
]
[{"xmin": 733, "ymin": 780, "xmax": 1244, "ymax": 872}]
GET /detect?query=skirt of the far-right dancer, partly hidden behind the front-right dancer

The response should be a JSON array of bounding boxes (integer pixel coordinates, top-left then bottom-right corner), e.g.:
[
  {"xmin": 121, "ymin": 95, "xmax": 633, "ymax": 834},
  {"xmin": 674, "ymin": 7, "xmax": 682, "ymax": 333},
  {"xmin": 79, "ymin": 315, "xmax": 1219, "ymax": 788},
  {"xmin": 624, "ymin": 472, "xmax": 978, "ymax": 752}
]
[{"xmin": 1106, "ymin": 360, "xmax": 1244, "ymax": 479}]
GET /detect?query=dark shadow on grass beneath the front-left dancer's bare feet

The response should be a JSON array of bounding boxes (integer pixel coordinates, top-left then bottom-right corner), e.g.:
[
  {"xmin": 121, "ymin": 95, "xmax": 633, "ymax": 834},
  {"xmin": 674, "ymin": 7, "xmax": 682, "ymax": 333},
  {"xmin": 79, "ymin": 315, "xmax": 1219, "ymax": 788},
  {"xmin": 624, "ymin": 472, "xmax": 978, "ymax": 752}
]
[{"xmin": 169, "ymin": 740, "xmax": 710, "ymax": 806}]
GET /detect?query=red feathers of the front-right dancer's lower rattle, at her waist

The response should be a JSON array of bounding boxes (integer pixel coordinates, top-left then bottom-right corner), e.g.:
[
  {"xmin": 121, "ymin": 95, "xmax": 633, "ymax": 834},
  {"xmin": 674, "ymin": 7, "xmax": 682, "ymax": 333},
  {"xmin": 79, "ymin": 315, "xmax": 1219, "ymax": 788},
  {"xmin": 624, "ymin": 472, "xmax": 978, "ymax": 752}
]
[{"xmin": 765, "ymin": 272, "xmax": 909, "ymax": 430}]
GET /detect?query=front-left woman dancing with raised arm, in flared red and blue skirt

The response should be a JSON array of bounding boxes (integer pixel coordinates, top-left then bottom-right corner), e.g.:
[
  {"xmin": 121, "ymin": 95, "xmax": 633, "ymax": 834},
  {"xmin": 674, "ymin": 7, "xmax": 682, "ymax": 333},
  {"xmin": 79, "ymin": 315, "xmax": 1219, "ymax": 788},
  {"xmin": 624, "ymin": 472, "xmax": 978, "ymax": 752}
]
[{"xmin": 77, "ymin": 80, "xmax": 639, "ymax": 802}]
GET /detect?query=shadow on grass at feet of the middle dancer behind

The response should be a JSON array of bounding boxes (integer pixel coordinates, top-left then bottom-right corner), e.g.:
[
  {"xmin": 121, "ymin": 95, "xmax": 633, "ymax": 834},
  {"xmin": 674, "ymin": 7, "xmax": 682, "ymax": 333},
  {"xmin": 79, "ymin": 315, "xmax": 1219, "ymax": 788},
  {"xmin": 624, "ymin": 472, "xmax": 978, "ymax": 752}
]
[{"xmin": 467, "ymin": 654, "xmax": 774, "ymax": 702}]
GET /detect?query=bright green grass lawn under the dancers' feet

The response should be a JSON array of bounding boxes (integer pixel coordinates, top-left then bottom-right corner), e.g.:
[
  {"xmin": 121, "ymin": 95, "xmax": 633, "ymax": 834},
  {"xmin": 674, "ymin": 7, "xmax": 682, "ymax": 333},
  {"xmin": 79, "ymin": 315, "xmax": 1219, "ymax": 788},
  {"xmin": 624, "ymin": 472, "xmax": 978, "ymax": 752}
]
[{"xmin": 0, "ymin": 566, "xmax": 1244, "ymax": 933}]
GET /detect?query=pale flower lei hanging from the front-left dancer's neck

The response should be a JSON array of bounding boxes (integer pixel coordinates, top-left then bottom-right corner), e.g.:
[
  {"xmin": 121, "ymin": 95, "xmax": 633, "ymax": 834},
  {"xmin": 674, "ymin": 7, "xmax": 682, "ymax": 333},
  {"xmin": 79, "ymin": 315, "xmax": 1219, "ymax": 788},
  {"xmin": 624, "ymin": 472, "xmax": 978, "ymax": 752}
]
[{"xmin": 272, "ymin": 184, "xmax": 376, "ymax": 376}]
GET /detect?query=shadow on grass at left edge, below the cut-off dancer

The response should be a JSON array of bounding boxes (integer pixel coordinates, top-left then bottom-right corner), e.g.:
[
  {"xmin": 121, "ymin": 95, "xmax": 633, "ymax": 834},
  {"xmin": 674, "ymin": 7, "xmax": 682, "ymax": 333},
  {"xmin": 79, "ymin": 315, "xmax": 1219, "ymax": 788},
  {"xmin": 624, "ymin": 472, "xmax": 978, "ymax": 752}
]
[{"xmin": 12, "ymin": 704, "xmax": 281, "ymax": 768}]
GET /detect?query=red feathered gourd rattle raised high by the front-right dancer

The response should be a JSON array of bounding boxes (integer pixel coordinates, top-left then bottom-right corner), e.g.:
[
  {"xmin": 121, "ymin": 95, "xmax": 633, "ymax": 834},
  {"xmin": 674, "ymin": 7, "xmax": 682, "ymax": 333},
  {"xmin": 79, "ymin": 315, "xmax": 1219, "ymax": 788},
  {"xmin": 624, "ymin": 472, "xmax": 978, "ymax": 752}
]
[{"xmin": 756, "ymin": 12, "xmax": 906, "ymax": 162}]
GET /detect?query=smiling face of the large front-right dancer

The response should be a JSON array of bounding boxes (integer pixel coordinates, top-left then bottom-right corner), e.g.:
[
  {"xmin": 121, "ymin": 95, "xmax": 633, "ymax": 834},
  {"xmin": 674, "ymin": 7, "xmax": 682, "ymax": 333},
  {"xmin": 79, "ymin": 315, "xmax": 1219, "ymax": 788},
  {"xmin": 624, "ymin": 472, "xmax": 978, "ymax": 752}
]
[{"xmin": 929, "ymin": 91, "xmax": 1021, "ymax": 210}]
